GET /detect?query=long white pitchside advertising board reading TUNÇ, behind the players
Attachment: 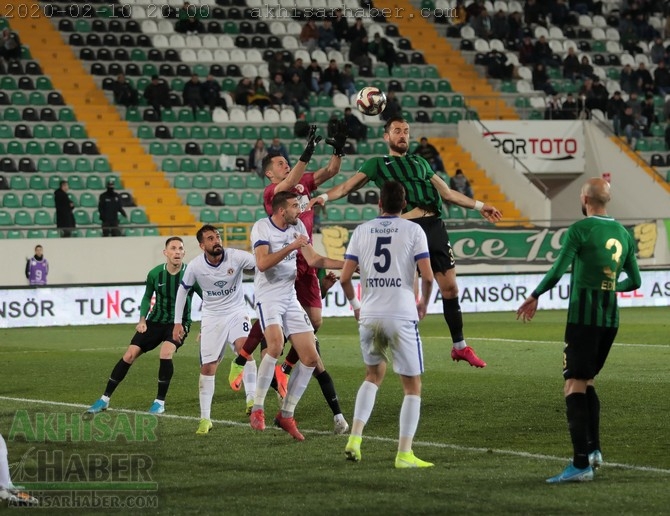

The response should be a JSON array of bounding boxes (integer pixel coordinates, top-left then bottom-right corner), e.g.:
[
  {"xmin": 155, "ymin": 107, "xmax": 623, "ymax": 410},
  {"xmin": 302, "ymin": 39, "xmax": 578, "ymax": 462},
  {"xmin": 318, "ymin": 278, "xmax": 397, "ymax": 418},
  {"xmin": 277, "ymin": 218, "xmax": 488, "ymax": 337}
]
[{"xmin": 0, "ymin": 271, "xmax": 670, "ymax": 328}]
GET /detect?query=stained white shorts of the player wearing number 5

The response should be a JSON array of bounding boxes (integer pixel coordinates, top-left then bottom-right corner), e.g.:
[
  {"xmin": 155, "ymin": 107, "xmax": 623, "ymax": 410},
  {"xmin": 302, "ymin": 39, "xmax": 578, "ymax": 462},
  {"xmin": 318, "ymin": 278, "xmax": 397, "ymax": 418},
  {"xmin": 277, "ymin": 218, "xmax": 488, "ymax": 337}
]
[{"xmin": 358, "ymin": 319, "xmax": 423, "ymax": 376}]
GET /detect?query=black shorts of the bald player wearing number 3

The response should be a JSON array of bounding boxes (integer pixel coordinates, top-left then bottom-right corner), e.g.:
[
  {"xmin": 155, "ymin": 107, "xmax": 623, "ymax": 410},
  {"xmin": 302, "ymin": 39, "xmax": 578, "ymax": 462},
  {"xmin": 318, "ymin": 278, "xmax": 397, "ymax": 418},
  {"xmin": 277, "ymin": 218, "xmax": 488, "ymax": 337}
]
[{"xmin": 563, "ymin": 323, "xmax": 619, "ymax": 380}]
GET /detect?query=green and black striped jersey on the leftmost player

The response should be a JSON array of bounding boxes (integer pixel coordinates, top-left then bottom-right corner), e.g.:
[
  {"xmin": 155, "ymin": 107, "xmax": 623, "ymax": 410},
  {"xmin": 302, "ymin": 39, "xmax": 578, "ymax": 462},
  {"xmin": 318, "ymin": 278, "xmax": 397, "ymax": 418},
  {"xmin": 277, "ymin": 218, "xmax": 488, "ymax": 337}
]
[{"xmin": 140, "ymin": 264, "xmax": 202, "ymax": 328}]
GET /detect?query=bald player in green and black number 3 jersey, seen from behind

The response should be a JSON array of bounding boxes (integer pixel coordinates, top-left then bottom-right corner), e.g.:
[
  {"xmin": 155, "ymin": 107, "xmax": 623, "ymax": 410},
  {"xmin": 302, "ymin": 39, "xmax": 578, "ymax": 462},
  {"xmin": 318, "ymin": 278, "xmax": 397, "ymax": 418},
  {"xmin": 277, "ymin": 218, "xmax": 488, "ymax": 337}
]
[{"xmin": 517, "ymin": 178, "xmax": 641, "ymax": 483}]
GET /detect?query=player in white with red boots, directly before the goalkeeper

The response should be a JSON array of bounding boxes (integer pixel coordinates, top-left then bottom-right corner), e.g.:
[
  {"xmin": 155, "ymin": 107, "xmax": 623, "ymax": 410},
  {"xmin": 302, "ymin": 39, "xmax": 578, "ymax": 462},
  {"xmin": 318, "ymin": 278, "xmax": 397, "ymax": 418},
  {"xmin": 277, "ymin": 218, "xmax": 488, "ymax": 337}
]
[{"xmin": 249, "ymin": 192, "xmax": 343, "ymax": 441}]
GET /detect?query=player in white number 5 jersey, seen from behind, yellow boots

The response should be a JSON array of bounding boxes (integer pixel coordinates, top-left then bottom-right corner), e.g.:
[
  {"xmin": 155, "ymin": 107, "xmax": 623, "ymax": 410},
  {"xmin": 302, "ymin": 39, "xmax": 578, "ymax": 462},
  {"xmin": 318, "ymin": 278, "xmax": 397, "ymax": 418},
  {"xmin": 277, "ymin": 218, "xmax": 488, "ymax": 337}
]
[{"xmin": 340, "ymin": 181, "xmax": 433, "ymax": 468}]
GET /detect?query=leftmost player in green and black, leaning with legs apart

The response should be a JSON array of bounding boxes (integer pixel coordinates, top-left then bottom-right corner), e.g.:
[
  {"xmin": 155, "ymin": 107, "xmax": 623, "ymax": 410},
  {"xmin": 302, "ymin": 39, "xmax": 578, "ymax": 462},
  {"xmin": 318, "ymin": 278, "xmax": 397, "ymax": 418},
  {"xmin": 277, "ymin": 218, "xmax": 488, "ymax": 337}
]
[{"xmin": 87, "ymin": 237, "xmax": 201, "ymax": 414}]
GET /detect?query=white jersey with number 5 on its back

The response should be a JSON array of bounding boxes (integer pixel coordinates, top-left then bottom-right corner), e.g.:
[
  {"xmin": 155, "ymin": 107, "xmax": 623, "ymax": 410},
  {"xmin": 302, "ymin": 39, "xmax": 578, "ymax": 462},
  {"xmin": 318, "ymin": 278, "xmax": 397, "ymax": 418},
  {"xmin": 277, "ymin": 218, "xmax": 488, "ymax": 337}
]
[{"xmin": 344, "ymin": 217, "xmax": 429, "ymax": 321}]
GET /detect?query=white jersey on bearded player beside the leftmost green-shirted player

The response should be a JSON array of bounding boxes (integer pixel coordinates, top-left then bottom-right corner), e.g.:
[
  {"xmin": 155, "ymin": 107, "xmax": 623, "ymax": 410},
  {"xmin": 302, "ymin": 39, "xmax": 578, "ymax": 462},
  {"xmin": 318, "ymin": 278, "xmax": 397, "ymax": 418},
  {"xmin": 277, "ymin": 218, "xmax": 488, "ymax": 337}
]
[{"xmin": 178, "ymin": 248, "xmax": 256, "ymax": 317}]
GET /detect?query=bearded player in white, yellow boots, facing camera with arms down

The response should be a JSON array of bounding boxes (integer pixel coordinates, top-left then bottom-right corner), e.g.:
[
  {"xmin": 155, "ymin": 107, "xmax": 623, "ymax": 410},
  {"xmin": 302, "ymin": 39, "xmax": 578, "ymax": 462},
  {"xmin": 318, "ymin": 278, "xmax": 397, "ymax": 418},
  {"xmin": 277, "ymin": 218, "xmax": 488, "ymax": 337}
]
[{"xmin": 173, "ymin": 225, "xmax": 256, "ymax": 435}]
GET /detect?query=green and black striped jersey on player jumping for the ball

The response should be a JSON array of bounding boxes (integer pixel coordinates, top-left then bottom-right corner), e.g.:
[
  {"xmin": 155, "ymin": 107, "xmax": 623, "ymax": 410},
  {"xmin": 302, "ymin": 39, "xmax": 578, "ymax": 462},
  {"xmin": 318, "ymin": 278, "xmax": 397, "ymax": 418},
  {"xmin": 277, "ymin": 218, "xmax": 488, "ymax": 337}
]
[{"xmin": 360, "ymin": 154, "xmax": 443, "ymax": 217}]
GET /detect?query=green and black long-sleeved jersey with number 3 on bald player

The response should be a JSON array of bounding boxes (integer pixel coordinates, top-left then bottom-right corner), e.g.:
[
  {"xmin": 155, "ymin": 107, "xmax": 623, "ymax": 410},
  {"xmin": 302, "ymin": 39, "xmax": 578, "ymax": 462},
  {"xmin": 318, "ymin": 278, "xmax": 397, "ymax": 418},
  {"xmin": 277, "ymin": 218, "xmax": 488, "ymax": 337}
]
[{"xmin": 533, "ymin": 216, "xmax": 641, "ymax": 328}]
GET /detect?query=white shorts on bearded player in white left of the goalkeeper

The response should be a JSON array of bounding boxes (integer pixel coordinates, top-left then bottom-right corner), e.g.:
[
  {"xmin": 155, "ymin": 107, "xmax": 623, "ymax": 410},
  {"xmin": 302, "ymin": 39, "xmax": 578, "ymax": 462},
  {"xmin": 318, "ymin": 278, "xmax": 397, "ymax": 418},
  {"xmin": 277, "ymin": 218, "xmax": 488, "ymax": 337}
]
[{"xmin": 200, "ymin": 312, "xmax": 251, "ymax": 365}]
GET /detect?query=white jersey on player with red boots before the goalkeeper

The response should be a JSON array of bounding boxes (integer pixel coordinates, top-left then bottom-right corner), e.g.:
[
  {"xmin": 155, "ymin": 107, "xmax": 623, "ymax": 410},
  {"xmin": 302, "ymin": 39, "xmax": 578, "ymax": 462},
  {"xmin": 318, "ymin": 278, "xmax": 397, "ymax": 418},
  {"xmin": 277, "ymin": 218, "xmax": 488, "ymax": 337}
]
[{"xmin": 251, "ymin": 217, "xmax": 311, "ymax": 303}]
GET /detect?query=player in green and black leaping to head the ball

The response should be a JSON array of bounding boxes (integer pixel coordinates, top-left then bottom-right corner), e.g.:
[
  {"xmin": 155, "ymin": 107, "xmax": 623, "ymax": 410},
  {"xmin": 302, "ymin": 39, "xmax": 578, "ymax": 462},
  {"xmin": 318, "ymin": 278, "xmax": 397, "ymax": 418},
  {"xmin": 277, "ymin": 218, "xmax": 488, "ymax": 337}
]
[{"xmin": 310, "ymin": 117, "xmax": 502, "ymax": 367}]
